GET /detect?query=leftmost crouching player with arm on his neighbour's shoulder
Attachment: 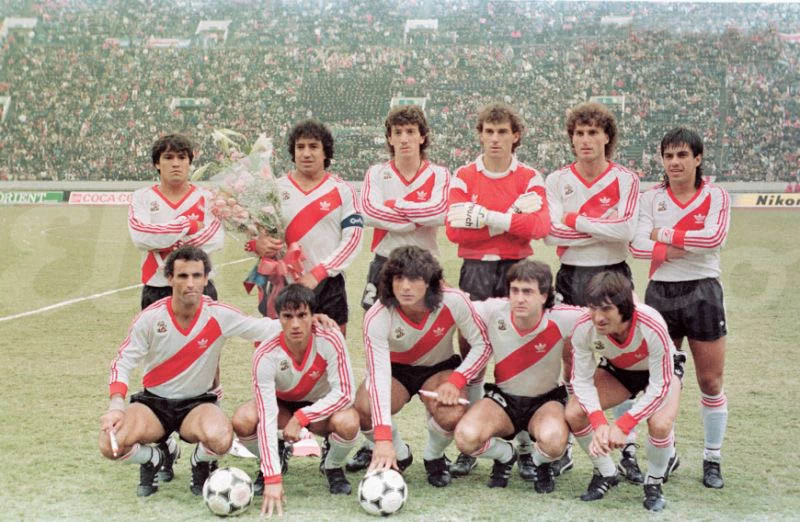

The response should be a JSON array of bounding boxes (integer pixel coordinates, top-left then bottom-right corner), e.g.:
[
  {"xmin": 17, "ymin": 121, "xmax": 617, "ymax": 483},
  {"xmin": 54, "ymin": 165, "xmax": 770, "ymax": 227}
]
[{"xmin": 99, "ymin": 246, "xmax": 288, "ymax": 497}]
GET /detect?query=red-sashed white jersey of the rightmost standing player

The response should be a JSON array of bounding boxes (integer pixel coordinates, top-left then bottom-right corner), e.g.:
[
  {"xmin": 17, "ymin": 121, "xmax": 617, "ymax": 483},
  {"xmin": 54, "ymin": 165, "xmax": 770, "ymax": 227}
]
[{"xmin": 631, "ymin": 182, "xmax": 731, "ymax": 281}]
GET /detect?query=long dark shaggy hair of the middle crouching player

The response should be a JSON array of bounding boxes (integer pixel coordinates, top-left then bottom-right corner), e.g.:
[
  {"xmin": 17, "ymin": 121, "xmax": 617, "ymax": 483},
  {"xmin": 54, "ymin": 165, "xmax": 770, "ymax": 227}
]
[{"xmin": 378, "ymin": 246, "xmax": 442, "ymax": 311}]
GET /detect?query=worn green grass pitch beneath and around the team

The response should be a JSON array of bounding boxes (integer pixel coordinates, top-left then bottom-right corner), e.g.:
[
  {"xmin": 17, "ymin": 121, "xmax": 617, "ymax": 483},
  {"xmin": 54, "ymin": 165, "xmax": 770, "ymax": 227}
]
[{"xmin": 0, "ymin": 206, "xmax": 800, "ymax": 521}]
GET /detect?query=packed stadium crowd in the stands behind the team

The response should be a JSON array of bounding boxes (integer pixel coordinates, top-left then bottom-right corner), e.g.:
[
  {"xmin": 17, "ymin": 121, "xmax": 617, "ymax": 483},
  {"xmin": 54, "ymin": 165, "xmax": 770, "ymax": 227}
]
[{"xmin": 0, "ymin": 0, "xmax": 800, "ymax": 181}]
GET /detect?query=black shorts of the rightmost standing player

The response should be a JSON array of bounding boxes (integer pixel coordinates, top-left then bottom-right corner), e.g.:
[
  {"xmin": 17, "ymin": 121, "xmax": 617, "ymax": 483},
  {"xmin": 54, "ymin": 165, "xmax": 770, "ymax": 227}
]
[{"xmin": 644, "ymin": 278, "xmax": 728, "ymax": 341}]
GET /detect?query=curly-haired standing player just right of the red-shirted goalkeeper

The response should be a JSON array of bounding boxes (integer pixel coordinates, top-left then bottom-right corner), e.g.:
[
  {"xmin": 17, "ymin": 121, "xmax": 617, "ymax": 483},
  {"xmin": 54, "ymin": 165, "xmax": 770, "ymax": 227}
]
[{"xmin": 544, "ymin": 103, "xmax": 644, "ymax": 484}]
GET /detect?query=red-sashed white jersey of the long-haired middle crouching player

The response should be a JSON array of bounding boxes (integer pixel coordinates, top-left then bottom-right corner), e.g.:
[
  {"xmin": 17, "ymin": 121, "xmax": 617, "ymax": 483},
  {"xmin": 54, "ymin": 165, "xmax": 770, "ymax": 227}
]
[{"xmin": 364, "ymin": 288, "xmax": 489, "ymax": 440}]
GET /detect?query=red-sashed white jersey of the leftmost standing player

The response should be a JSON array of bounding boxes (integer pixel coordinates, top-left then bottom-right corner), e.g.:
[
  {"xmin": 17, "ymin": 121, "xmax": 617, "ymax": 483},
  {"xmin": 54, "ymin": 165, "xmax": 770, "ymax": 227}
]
[{"xmin": 128, "ymin": 185, "xmax": 225, "ymax": 286}]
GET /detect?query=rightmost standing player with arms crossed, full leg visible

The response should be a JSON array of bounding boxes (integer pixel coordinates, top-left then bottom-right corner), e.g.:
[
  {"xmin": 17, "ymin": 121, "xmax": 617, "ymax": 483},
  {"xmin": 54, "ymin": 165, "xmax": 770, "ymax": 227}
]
[{"xmin": 631, "ymin": 127, "xmax": 731, "ymax": 488}]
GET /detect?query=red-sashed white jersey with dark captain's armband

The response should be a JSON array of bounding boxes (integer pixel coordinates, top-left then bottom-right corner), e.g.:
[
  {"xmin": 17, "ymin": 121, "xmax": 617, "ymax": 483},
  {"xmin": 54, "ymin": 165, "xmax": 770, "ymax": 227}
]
[{"xmin": 277, "ymin": 173, "xmax": 364, "ymax": 281}]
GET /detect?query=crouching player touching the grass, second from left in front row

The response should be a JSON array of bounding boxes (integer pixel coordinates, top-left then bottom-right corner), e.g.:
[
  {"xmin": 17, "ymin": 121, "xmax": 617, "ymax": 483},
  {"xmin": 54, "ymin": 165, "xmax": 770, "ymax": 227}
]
[{"xmin": 233, "ymin": 284, "xmax": 359, "ymax": 515}]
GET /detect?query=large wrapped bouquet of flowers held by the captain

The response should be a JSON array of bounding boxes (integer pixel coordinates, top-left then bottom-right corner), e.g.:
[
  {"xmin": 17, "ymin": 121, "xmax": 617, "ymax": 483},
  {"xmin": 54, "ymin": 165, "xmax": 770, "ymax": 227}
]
[{"xmin": 192, "ymin": 129, "xmax": 305, "ymax": 318}]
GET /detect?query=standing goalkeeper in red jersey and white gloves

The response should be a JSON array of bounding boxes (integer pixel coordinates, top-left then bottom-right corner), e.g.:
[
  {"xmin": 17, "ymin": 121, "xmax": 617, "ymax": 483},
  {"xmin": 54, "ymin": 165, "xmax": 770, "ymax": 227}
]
[{"xmin": 445, "ymin": 104, "xmax": 550, "ymax": 476}]
